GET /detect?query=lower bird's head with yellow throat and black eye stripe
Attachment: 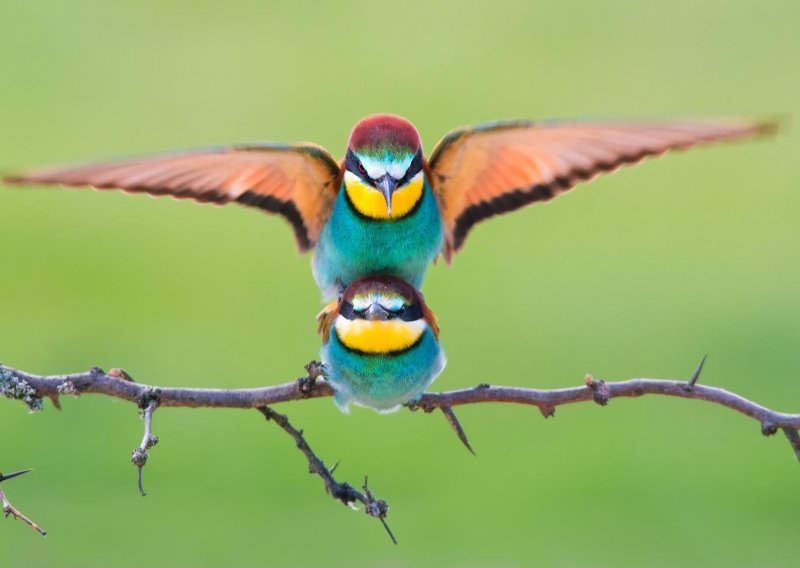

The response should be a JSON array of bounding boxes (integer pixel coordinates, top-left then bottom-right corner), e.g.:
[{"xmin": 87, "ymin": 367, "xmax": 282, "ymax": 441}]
[{"xmin": 322, "ymin": 276, "xmax": 439, "ymax": 354}]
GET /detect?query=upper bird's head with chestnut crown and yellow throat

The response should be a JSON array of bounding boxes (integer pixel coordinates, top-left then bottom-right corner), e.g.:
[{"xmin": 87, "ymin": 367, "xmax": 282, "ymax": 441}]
[{"xmin": 344, "ymin": 114, "xmax": 424, "ymax": 219}]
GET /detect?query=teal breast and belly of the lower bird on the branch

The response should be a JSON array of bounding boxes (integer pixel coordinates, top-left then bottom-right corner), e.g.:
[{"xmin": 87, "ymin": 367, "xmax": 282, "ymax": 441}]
[{"xmin": 321, "ymin": 329, "xmax": 446, "ymax": 412}]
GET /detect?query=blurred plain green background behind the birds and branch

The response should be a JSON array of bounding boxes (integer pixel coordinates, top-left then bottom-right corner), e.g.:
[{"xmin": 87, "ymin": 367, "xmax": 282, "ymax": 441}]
[{"xmin": 0, "ymin": 0, "xmax": 800, "ymax": 567}]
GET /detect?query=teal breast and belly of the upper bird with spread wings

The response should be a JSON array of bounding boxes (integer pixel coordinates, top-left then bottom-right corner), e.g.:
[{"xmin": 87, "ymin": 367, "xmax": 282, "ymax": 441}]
[{"xmin": 313, "ymin": 182, "xmax": 444, "ymax": 299}]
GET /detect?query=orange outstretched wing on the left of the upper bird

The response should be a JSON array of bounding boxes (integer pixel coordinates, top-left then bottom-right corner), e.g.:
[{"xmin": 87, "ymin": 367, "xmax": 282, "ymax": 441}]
[{"xmin": 3, "ymin": 144, "xmax": 340, "ymax": 251}]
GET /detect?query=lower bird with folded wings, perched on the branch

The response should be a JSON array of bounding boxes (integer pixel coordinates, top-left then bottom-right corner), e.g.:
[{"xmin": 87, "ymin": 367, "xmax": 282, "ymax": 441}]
[{"xmin": 320, "ymin": 275, "xmax": 447, "ymax": 414}]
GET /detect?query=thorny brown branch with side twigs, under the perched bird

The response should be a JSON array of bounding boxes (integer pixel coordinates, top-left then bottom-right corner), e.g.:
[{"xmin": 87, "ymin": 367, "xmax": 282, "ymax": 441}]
[{"xmin": 0, "ymin": 357, "xmax": 800, "ymax": 542}]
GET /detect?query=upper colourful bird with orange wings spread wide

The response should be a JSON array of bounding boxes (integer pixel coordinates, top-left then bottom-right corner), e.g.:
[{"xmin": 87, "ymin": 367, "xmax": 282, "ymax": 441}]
[{"xmin": 5, "ymin": 115, "xmax": 775, "ymax": 299}]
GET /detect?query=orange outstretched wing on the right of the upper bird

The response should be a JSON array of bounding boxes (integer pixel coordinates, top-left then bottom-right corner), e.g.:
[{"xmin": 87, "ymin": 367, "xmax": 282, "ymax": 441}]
[{"xmin": 429, "ymin": 121, "xmax": 776, "ymax": 260}]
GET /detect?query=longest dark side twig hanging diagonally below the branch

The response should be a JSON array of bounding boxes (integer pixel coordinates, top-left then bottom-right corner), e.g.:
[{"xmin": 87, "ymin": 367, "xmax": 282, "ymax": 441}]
[{"xmin": 258, "ymin": 406, "xmax": 397, "ymax": 544}]
